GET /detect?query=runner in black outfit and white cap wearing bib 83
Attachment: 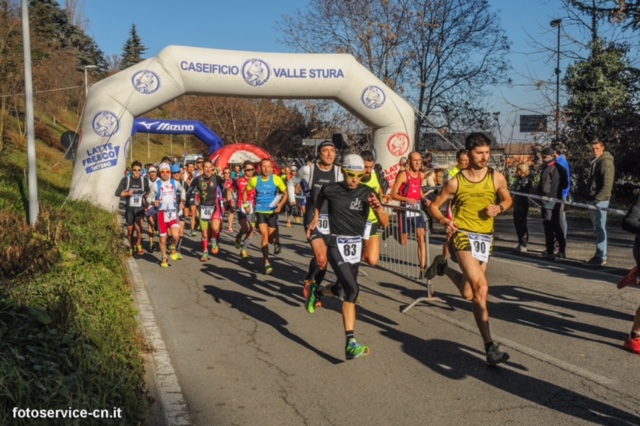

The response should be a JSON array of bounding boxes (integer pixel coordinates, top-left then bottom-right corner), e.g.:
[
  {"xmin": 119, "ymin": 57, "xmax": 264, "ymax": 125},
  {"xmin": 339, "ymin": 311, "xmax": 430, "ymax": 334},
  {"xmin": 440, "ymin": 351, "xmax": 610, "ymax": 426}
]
[{"xmin": 306, "ymin": 154, "xmax": 389, "ymax": 360}]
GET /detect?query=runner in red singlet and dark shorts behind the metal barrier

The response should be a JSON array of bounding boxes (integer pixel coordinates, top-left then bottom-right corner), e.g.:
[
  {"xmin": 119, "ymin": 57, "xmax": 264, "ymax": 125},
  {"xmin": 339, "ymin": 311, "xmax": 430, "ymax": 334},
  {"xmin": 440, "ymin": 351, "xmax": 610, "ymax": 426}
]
[{"xmin": 391, "ymin": 151, "xmax": 427, "ymax": 279}]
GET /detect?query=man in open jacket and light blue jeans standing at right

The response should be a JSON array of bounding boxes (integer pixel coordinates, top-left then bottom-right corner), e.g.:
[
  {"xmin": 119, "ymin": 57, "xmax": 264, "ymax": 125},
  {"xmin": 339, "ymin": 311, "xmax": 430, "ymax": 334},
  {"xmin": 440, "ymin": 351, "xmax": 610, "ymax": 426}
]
[{"xmin": 587, "ymin": 138, "xmax": 615, "ymax": 266}]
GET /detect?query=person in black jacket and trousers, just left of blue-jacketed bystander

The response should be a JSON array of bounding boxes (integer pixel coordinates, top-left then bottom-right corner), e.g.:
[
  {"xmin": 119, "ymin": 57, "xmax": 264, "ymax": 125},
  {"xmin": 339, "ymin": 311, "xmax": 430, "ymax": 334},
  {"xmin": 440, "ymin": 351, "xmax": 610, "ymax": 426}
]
[{"xmin": 539, "ymin": 147, "xmax": 567, "ymax": 259}]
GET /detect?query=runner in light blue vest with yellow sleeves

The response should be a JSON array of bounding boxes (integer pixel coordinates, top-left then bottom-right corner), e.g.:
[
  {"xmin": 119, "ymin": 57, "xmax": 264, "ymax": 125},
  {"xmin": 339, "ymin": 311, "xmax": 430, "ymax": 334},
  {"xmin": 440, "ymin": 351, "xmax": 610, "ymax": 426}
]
[{"xmin": 242, "ymin": 158, "xmax": 287, "ymax": 275}]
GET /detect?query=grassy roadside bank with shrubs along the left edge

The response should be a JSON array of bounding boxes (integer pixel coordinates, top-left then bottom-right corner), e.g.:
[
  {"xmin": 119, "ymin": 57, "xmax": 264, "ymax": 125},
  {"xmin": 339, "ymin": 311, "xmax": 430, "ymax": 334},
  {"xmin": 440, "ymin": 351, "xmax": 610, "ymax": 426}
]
[{"xmin": 0, "ymin": 136, "xmax": 148, "ymax": 425}]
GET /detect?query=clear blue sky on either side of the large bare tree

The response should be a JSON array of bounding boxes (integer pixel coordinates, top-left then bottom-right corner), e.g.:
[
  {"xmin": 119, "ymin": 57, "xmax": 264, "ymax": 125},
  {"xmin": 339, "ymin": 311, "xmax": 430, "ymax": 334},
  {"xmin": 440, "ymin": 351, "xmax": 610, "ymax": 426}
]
[{"xmin": 70, "ymin": 0, "xmax": 584, "ymax": 143}]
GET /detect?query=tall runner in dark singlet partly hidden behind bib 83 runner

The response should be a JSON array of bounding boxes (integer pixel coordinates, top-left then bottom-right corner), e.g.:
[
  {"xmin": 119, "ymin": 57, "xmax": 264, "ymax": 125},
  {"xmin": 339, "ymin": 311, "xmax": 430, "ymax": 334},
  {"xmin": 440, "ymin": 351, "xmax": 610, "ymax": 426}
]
[{"xmin": 288, "ymin": 140, "xmax": 342, "ymax": 298}]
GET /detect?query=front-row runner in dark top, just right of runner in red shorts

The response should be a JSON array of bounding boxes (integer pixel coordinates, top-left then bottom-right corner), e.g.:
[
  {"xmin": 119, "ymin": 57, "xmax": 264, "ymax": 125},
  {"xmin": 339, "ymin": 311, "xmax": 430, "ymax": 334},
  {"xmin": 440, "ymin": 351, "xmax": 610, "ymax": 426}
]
[{"xmin": 189, "ymin": 160, "xmax": 222, "ymax": 262}]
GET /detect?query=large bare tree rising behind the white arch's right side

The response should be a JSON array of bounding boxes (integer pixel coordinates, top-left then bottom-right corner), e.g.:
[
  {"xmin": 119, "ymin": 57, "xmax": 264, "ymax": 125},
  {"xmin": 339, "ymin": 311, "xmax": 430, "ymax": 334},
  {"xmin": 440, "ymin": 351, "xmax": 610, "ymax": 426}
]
[{"xmin": 277, "ymin": 0, "xmax": 509, "ymax": 145}]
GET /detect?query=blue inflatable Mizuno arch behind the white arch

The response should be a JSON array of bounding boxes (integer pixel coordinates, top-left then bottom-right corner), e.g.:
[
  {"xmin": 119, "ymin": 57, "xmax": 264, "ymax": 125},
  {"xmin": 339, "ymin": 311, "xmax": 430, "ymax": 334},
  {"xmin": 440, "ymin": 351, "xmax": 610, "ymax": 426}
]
[{"xmin": 131, "ymin": 118, "xmax": 224, "ymax": 155}]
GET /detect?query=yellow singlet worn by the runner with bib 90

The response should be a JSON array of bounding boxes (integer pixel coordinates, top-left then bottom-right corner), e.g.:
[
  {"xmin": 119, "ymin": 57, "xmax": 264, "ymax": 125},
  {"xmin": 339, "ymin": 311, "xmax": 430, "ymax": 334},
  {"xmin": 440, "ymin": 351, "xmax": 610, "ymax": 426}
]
[{"xmin": 453, "ymin": 168, "xmax": 498, "ymax": 234}]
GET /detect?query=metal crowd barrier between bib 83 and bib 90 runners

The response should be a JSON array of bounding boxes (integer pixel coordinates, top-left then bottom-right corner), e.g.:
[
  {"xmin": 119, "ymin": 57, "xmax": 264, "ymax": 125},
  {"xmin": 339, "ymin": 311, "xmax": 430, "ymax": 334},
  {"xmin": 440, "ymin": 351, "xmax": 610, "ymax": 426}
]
[{"xmin": 378, "ymin": 204, "xmax": 442, "ymax": 313}]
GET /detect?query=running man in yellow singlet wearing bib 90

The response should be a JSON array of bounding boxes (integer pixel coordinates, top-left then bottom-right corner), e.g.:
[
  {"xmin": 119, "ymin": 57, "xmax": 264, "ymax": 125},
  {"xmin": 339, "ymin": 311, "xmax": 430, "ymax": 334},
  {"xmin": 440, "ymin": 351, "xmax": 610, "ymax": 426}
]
[{"xmin": 427, "ymin": 133, "xmax": 513, "ymax": 365}]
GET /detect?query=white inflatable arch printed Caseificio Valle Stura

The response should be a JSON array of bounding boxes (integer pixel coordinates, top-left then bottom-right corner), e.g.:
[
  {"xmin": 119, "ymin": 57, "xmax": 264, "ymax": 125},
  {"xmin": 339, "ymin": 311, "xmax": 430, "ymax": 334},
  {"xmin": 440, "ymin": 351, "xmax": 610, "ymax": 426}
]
[{"xmin": 70, "ymin": 46, "xmax": 414, "ymax": 210}]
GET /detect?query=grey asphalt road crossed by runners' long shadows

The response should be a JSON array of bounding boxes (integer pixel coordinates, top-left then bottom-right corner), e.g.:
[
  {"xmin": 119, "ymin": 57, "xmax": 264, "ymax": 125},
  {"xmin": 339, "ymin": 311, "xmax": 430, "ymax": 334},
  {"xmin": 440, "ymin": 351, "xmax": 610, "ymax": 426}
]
[{"xmin": 130, "ymin": 217, "xmax": 640, "ymax": 425}]
